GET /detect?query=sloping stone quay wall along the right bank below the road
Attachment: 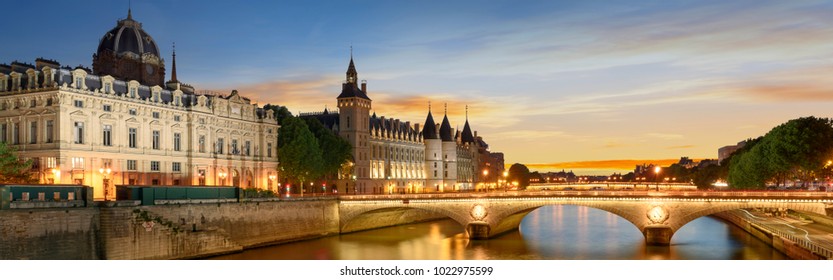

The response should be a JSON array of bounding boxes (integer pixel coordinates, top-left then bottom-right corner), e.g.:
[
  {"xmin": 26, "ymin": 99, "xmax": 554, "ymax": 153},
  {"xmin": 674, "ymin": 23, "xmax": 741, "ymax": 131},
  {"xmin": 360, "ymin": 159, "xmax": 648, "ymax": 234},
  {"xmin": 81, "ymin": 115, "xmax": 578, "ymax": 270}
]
[{"xmin": 714, "ymin": 210, "xmax": 828, "ymax": 260}]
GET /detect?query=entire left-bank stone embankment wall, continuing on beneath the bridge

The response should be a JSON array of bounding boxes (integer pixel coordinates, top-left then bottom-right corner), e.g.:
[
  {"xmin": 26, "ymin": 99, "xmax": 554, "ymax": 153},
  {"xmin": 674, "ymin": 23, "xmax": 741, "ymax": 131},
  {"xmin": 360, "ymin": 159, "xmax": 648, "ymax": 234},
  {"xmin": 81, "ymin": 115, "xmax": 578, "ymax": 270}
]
[{"xmin": 0, "ymin": 198, "xmax": 444, "ymax": 260}]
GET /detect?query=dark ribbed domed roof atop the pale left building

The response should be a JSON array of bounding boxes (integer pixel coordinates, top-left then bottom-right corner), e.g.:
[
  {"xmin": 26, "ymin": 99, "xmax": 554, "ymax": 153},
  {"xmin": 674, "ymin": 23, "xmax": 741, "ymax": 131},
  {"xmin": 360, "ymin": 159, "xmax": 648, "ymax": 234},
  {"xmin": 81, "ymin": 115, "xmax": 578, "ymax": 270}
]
[{"xmin": 96, "ymin": 10, "xmax": 161, "ymax": 58}]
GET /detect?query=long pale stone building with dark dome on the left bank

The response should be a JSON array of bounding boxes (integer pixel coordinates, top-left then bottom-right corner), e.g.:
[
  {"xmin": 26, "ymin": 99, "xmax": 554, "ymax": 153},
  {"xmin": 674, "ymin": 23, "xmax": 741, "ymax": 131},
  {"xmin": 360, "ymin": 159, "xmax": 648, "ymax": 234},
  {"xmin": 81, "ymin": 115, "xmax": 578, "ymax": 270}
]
[{"xmin": 0, "ymin": 11, "xmax": 278, "ymax": 199}]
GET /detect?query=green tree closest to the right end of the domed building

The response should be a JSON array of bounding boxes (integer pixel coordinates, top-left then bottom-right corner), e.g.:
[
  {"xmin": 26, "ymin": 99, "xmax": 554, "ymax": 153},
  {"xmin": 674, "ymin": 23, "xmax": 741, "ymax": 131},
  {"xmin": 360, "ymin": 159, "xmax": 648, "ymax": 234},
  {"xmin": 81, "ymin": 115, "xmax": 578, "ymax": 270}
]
[{"xmin": 278, "ymin": 117, "xmax": 321, "ymax": 195}]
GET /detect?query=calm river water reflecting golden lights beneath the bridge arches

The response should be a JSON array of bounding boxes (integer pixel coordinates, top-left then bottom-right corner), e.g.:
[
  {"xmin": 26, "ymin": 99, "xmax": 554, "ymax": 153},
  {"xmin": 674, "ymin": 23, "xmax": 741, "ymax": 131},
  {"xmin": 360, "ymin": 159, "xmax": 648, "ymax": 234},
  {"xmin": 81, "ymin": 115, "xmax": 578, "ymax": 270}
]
[{"xmin": 206, "ymin": 205, "xmax": 787, "ymax": 260}]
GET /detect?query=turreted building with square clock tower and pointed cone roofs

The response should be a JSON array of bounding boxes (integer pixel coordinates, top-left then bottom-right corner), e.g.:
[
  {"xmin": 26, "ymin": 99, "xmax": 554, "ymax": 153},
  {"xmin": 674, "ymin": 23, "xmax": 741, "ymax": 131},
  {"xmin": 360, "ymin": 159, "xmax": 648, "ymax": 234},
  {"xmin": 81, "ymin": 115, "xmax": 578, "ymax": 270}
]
[{"xmin": 299, "ymin": 57, "xmax": 503, "ymax": 193}]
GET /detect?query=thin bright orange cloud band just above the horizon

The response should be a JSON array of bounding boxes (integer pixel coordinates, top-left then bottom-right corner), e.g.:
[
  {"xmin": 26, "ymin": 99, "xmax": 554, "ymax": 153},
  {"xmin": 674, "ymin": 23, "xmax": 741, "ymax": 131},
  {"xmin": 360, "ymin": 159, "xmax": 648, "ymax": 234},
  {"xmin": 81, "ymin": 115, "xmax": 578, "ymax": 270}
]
[{"xmin": 520, "ymin": 159, "xmax": 701, "ymax": 172}]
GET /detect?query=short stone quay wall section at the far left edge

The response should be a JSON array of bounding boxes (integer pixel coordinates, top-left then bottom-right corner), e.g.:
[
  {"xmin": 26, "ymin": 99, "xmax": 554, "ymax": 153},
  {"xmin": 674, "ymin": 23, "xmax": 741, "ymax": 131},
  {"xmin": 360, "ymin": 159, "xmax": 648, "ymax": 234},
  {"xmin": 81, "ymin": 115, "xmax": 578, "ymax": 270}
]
[{"xmin": 0, "ymin": 207, "xmax": 99, "ymax": 260}]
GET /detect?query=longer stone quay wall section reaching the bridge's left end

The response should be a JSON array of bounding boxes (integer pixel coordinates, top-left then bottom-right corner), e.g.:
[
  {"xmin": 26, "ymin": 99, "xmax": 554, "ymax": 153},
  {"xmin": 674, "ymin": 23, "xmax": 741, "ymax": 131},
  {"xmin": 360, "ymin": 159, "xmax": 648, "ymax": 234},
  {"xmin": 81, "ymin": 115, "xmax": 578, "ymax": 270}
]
[{"xmin": 101, "ymin": 199, "xmax": 338, "ymax": 260}]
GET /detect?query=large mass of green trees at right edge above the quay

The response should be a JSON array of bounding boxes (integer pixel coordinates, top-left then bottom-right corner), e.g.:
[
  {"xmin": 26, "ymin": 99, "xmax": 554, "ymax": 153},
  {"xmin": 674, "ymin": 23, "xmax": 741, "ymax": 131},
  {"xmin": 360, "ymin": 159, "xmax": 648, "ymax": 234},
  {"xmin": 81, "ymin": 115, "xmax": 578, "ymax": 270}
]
[{"xmin": 728, "ymin": 117, "xmax": 833, "ymax": 188}]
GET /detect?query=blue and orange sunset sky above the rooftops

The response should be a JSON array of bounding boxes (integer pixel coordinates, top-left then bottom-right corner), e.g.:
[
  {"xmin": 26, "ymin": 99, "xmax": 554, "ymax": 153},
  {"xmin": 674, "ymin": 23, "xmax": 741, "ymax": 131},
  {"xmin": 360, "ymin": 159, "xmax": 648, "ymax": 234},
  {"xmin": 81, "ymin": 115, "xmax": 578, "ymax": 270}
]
[{"xmin": 0, "ymin": 0, "xmax": 833, "ymax": 174}]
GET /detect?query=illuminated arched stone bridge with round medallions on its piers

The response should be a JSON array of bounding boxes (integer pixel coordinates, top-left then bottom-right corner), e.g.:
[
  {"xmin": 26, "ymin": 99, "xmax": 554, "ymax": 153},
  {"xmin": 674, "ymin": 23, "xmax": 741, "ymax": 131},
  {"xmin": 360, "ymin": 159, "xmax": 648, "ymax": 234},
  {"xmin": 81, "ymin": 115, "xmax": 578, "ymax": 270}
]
[{"xmin": 339, "ymin": 191, "xmax": 833, "ymax": 245}]
